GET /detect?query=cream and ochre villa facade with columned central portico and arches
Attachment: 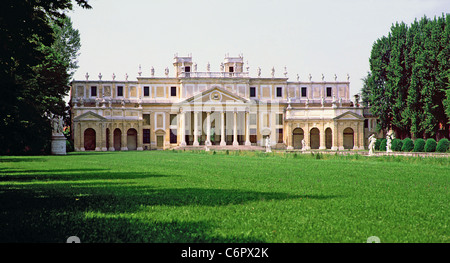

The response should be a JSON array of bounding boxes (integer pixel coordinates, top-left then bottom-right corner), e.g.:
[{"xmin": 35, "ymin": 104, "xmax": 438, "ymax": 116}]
[{"xmin": 70, "ymin": 56, "xmax": 376, "ymax": 151}]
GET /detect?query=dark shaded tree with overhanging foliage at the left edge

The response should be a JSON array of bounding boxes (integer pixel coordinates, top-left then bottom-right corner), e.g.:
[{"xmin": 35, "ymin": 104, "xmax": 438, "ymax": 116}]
[{"xmin": 0, "ymin": 0, "xmax": 91, "ymax": 154}]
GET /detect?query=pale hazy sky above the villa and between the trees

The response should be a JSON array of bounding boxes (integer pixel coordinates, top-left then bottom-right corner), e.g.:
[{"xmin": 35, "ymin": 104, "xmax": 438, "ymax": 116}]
[{"xmin": 68, "ymin": 0, "xmax": 450, "ymax": 96}]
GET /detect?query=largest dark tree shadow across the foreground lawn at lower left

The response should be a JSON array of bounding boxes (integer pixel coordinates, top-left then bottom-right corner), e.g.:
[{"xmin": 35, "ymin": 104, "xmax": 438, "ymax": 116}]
[{"xmin": 0, "ymin": 179, "xmax": 337, "ymax": 243}]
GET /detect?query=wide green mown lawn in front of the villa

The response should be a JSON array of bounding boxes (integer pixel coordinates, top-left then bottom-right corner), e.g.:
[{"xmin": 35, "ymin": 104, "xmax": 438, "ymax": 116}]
[{"xmin": 0, "ymin": 151, "xmax": 450, "ymax": 243}]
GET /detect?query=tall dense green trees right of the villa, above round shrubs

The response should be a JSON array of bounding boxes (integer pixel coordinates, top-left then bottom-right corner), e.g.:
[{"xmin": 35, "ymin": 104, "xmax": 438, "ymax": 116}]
[{"xmin": 362, "ymin": 14, "xmax": 450, "ymax": 138}]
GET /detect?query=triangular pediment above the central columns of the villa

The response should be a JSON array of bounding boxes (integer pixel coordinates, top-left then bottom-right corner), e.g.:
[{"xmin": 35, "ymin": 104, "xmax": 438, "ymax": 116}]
[{"xmin": 184, "ymin": 87, "xmax": 248, "ymax": 103}]
